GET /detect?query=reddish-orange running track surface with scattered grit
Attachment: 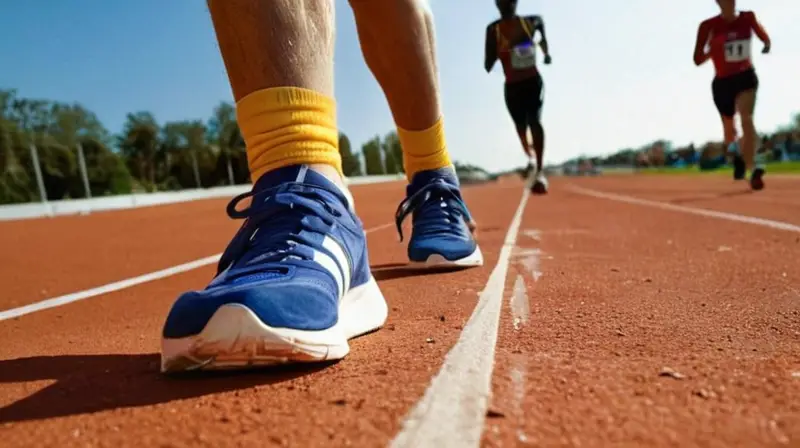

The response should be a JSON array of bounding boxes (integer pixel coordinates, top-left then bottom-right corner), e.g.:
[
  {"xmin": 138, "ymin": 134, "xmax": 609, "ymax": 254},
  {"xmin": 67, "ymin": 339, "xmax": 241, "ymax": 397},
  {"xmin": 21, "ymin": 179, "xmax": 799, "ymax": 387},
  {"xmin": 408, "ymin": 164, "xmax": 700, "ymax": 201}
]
[{"xmin": 0, "ymin": 176, "xmax": 800, "ymax": 448}]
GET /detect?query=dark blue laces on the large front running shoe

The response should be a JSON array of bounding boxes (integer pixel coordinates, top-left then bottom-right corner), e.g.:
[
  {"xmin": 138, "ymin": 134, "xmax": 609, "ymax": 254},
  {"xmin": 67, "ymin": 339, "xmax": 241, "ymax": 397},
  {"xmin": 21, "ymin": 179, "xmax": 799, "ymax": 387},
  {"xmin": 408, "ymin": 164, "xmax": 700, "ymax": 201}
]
[{"xmin": 217, "ymin": 182, "xmax": 342, "ymax": 276}]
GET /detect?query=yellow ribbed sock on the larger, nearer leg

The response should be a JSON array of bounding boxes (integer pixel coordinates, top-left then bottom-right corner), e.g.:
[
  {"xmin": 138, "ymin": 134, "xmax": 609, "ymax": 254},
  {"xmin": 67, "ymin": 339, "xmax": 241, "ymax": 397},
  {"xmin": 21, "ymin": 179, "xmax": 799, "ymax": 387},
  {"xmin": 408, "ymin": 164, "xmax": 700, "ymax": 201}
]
[{"xmin": 236, "ymin": 87, "xmax": 342, "ymax": 183}]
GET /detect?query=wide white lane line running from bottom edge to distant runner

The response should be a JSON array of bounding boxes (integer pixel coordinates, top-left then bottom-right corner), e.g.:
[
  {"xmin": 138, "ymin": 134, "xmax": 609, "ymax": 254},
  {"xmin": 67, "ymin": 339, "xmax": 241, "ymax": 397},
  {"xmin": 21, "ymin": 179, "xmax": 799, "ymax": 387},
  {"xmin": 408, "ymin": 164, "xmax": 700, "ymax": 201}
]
[{"xmin": 390, "ymin": 183, "xmax": 530, "ymax": 448}]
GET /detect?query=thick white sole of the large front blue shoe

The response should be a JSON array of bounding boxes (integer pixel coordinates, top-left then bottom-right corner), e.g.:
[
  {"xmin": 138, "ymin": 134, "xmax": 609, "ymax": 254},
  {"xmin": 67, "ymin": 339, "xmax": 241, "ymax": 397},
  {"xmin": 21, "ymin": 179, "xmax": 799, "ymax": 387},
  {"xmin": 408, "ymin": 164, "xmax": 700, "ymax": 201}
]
[{"xmin": 161, "ymin": 277, "xmax": 389, "ymax": 373}]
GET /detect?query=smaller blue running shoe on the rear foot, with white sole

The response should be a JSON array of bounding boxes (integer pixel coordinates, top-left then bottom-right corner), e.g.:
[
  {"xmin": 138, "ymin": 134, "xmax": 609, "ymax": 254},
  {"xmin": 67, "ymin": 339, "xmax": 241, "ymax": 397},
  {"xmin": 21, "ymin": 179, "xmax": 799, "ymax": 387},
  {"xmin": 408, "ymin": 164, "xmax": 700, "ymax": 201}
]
[{"xmin": 395, "ymin": 168, "xmax": 483, "ymax": 268}]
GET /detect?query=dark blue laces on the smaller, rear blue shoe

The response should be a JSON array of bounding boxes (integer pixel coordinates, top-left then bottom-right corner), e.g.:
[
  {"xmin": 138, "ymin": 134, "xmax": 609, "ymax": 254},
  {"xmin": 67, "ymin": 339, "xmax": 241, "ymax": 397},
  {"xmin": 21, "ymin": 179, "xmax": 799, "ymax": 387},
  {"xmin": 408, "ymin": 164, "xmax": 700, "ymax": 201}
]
[{"xmin": 395, "ymin": 179, "xmax": 472, "ymax": 241}]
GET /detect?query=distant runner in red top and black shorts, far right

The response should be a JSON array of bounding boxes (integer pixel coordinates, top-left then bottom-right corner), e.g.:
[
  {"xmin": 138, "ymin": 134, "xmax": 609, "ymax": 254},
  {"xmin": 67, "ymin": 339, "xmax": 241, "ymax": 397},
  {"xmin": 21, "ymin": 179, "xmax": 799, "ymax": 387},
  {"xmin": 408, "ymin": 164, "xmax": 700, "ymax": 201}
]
[{"xmin": 694, "ymin": 0, "xmax": 771, "ymax": 190}]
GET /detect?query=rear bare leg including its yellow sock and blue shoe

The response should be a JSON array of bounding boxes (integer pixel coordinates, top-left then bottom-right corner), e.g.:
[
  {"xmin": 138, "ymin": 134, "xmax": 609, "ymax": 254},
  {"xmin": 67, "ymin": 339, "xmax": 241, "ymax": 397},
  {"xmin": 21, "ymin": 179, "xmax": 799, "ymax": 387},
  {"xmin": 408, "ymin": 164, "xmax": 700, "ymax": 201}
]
[{"xmin": 350, "ymin": 0, "xmax": 483, "ymax": 266}]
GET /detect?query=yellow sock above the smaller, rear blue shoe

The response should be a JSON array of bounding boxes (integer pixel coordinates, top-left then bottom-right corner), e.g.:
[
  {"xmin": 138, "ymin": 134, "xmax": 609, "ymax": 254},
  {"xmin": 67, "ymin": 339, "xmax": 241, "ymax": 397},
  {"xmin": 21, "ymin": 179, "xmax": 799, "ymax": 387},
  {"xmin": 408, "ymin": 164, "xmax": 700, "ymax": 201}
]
[{"xmin": 397, "ymin": 118, "xmax": 452, "ymax": 182}]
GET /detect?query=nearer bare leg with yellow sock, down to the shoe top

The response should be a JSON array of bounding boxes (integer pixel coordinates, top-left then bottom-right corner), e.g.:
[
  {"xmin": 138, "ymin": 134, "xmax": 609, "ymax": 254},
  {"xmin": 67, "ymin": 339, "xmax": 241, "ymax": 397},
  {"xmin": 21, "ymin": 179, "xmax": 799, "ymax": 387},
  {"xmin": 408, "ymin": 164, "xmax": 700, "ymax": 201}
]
[{"xmin": 208, "ymin": 0, "xmax": 343, "ymax": 186}]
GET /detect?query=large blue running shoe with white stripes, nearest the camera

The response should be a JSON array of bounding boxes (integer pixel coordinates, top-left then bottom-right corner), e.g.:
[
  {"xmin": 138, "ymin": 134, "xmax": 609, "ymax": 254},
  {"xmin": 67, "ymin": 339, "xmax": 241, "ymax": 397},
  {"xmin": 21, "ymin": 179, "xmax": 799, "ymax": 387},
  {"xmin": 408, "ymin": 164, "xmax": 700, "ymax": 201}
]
[{"xmin": 161, "ymin": 166, "xmax": 388, "ymax": 372}]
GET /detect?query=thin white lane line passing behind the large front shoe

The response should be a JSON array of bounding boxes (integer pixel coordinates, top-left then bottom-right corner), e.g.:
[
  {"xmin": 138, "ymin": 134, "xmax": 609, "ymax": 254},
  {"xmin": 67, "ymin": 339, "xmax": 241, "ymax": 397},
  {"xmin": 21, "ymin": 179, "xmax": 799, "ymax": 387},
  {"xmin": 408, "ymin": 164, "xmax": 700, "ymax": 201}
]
[{"xmin": 0, "ymin": 222, "xmax": 394, "ymax": 321}]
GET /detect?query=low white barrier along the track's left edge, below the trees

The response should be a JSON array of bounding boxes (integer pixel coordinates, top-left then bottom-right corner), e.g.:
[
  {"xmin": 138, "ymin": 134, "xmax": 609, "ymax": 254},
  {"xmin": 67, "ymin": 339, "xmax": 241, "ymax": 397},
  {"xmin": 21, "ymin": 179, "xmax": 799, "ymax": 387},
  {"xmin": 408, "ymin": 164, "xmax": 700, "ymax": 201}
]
[{"xmin": 0, "ymin": 174, "xmax": 405, "ymax": 221}]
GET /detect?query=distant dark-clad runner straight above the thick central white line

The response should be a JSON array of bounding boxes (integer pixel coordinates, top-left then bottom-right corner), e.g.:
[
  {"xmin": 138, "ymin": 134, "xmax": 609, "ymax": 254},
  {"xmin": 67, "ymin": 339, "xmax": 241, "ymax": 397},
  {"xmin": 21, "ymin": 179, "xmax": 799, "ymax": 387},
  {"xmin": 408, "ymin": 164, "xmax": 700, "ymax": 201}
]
[{"xmin": 484, "ymin": 0, "xmax": 551, "ymax": 194}]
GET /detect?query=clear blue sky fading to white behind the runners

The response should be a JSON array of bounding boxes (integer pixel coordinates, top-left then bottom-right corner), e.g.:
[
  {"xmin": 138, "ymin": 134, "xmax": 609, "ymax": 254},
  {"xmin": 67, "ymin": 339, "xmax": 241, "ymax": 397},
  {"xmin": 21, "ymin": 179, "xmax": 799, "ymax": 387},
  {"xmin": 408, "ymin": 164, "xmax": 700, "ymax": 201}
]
[{"xmin": 0, "ymin": 0, "xmax": 800, "ymax": 170}]
